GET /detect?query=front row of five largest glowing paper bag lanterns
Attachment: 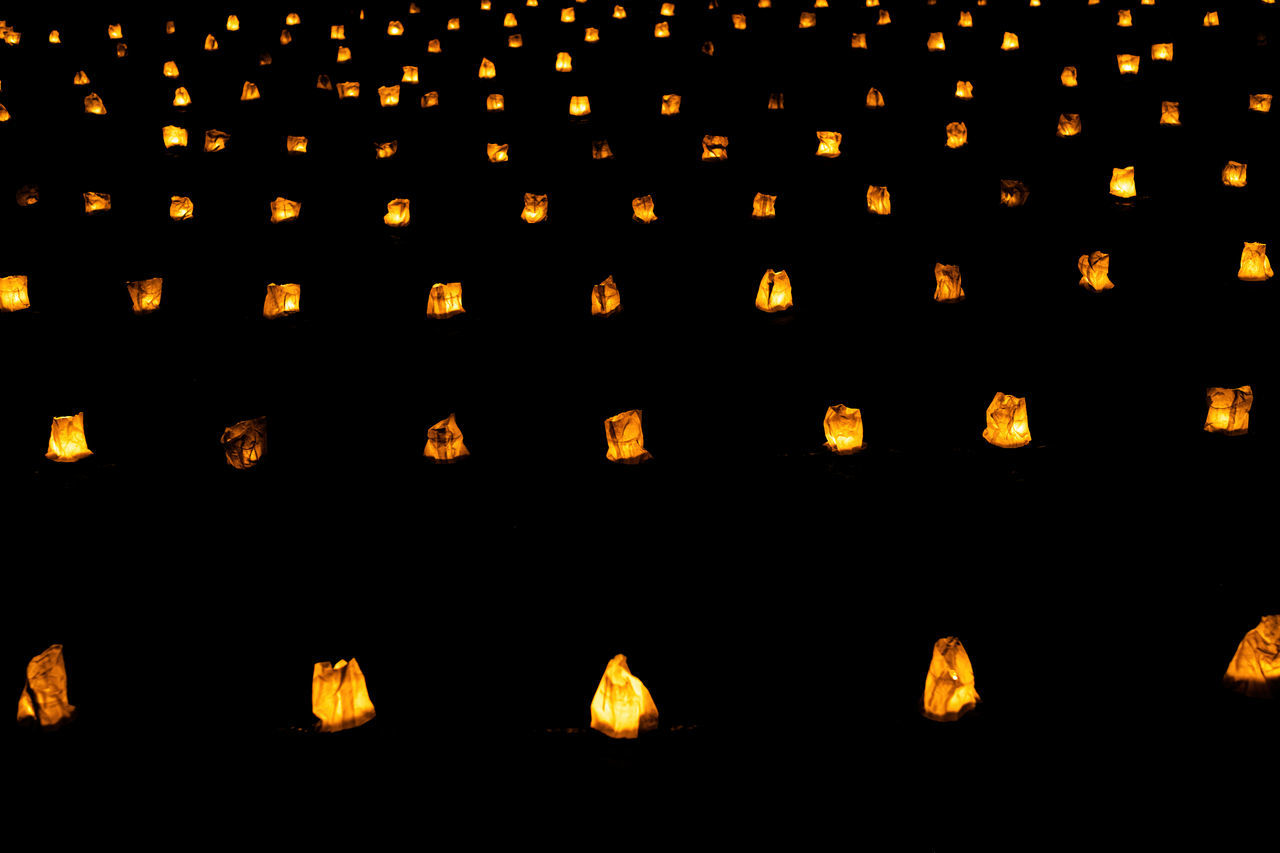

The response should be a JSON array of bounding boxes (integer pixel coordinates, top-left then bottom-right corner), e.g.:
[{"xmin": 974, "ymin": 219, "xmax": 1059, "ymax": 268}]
[{"xmin": 18, "ymin": 615, "xmax": 1280, "ymax": 739}]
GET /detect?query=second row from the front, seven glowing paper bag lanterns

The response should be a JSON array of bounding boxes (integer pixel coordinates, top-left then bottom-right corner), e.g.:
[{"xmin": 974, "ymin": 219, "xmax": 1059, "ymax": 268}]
[{"xmin": 30, "ymin": 384, "xmax": 1253, "ymax": 470}]
